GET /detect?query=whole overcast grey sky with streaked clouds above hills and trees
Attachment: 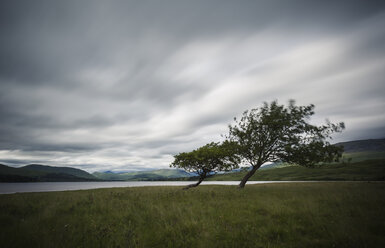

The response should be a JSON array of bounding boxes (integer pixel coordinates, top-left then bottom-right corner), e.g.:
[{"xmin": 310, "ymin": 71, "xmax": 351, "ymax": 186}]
[{"xmin": 0, "ymin": 0, "xmax": 385, "ymax": 172}]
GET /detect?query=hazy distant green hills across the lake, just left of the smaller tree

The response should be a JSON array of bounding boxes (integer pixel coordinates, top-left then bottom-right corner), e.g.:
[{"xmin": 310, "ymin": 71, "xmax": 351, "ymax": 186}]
[{"xmin": 93, "ymin": 169, "xmax": 191, "ymax": 181}]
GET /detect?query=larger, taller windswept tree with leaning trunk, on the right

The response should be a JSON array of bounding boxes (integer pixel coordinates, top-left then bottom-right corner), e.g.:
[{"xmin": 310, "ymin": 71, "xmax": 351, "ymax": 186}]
[{"xmin": 228, "ymin": 100, "xmax": 345, "ymax": 188}]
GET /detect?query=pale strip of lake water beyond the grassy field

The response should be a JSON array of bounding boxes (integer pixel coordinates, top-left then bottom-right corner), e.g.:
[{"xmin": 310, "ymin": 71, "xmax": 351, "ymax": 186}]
[{"xmin": 0, "ymin": 181, "xmax": 308, "ymax": 194}]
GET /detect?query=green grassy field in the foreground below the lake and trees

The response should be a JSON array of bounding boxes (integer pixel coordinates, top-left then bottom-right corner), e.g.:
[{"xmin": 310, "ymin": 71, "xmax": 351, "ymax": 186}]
[{"xmin": 0, "ymin": 182, "xmax": 385, "ymax": 248}]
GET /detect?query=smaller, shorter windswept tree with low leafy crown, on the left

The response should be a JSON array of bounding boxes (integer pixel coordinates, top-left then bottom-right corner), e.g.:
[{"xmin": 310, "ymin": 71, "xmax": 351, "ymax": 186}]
[{"xmin": 170, "ymin": 141, "xmax": 240, "ymax": 189}]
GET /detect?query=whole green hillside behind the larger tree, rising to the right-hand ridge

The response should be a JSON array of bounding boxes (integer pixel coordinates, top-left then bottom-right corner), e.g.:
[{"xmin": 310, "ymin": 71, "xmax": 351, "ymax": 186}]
[{"xmin": 213, "ymin": 139, "xmax": 385, "ymax": 180}]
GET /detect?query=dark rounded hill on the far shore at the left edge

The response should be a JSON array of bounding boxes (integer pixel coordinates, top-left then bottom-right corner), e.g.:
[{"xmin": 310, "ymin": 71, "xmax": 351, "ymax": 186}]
[{"xmin": 0, "ymin": 164, "xmax": 99, "ymax": 182}]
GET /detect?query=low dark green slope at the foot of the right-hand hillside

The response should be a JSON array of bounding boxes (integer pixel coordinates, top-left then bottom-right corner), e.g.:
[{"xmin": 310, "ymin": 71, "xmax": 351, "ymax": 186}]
[{"xmin": 206, "ymin": 159, "xmax": 385, "ymax": 181}]
